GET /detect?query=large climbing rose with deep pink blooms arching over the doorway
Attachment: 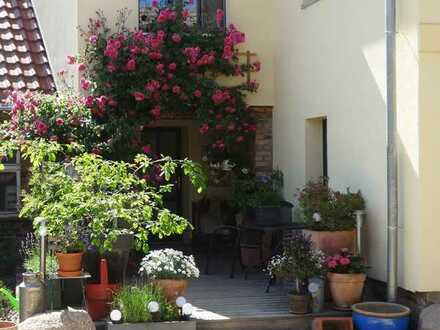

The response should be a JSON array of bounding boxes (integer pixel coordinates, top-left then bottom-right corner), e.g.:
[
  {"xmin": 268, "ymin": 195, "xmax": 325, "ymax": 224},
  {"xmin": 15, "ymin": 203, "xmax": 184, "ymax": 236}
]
[{"xmin": 77, "ymin": 7, "xmax": 261, "ymax": 163}]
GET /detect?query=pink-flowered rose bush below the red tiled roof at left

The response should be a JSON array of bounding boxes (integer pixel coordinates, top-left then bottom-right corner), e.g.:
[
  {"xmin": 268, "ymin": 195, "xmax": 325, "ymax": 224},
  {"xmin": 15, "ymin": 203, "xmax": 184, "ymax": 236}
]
[{"xmin": 0, "ymin": 92, "xmax": 100, "ymax": 155}]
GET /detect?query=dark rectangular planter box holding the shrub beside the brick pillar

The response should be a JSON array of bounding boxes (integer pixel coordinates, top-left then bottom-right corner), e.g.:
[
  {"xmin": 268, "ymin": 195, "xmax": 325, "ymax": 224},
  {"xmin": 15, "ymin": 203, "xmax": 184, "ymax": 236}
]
[{"xmin": 246, "ymin": 202, "xmax": 293, "ymax": 226}]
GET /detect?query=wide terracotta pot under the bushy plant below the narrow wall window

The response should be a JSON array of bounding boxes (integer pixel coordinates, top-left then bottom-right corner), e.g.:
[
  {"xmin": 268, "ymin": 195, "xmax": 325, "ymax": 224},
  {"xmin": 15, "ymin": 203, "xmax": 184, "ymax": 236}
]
[{"xmin": 303, "ymin": 229, "xmax": 356, "ymax": 256}]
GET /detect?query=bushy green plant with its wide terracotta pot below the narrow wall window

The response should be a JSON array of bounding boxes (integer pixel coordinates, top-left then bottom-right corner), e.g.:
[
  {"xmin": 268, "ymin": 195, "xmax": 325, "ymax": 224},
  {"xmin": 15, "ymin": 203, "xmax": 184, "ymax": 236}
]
[{"xmin": 298, "ymin": 179, "xmax": 365, "ymax": 255}]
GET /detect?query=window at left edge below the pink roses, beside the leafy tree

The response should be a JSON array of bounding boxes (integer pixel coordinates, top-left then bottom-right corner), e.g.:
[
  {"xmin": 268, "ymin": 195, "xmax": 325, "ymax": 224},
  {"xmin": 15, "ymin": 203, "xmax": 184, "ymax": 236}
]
[{"xmin": 0, "ymin": 155, "xmax": 21, "ymax": 216}]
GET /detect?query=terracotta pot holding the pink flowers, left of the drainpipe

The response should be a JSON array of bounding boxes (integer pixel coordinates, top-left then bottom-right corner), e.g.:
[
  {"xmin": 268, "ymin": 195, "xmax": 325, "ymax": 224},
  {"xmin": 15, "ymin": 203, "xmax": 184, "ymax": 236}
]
[{"xmin": 327, "ymin": 273, "xmax": 367, "ymax": 310}]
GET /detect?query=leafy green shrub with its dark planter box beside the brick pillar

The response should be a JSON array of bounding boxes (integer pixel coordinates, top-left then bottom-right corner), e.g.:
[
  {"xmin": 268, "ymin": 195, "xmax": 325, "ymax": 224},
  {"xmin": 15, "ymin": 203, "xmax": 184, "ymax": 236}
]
[{"xmin": 232, "ymin": 170, "xmax": 293, "ymax": 226}]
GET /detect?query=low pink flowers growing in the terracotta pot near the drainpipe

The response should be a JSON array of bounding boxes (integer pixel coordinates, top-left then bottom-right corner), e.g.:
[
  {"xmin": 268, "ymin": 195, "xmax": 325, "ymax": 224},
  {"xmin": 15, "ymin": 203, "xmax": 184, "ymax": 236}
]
[{"xmin": 326, "ymin": 249, "xmax": 368, "ymax": 274}]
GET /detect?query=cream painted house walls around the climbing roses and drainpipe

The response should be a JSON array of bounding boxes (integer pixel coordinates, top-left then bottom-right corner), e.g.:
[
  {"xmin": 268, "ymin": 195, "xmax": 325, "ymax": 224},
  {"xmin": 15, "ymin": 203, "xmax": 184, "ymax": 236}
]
[{"xmin": 34, "ymin": 0, "xmax": 440, "ymax": 291}]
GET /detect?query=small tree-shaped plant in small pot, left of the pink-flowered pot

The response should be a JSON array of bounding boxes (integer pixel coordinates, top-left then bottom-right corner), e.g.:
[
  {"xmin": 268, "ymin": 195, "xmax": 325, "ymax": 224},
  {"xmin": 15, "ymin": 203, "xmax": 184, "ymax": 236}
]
[{"xmin": 268, "ymin": 233, "xmax": 325, "ymax": 314}]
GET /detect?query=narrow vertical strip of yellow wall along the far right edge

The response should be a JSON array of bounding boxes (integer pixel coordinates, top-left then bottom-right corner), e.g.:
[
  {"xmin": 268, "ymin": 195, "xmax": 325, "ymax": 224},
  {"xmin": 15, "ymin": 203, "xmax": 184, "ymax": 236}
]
[{"xmin": 418, "ymin": 0, "xmax": 440, "ymax": 291}]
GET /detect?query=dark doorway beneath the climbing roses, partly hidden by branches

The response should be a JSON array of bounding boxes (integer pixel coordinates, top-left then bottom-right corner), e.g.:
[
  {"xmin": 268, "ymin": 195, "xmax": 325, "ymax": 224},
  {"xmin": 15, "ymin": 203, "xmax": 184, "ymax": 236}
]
[{"xmin": 145, "ymin": 127, "xmax": 182, "ymax": 215}]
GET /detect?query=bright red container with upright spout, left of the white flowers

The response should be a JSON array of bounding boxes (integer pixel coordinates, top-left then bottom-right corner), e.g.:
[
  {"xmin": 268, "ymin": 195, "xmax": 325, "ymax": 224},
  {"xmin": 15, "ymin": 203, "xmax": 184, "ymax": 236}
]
[{"xmin": 86, "ymin": 259, "xmax": 120, "ymax": 321}]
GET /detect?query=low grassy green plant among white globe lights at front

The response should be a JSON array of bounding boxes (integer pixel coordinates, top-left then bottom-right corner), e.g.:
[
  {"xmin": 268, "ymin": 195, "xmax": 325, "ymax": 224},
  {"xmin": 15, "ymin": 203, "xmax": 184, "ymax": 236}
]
[{"xmin": 113, "ymin": 284, "xmax": 179, "ymax": 323}]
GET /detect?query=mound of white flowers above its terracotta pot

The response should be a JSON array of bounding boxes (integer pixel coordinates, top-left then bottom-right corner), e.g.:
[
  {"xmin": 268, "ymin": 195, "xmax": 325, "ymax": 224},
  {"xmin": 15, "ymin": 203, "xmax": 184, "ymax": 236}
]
[{"xmin": 139, "ymin": 249, "xmax": 200, "ymax": 280}]
